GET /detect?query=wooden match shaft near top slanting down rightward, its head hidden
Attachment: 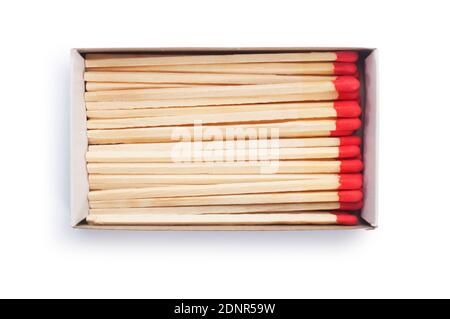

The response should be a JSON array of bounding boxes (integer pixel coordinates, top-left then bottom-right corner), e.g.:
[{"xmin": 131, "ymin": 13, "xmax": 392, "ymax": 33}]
[{"xmin": 84, "ymin": 71, "xmax": 336, "ymax": 85}]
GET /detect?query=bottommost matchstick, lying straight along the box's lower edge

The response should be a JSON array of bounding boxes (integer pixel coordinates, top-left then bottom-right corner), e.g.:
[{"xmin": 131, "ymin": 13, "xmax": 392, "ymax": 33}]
[{"xmin": 86, "ymin": 212, "xmax": 358, "ymax": 225}]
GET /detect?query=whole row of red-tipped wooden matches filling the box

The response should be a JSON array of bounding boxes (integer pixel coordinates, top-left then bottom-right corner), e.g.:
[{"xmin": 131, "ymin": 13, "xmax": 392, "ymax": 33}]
[{"xmin": 85, "ymin": 52, "xmax": 363, "ymax": 226}]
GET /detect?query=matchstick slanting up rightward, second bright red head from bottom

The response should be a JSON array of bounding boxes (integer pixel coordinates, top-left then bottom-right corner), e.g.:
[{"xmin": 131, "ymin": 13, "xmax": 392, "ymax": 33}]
[{"xmin": 89, "ymin": 190, "xmax": 363, "ymax": 209}]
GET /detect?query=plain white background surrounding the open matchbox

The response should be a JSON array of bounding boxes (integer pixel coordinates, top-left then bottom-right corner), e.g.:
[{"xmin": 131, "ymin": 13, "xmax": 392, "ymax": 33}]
[{"xmin": 0, "ymin": 0, "xmax": 450, "ymax": 298}]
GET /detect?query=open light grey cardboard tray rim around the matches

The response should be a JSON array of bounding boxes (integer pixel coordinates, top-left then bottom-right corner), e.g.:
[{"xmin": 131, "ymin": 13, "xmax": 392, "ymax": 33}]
[{"xmin": 70, "ymin": 47, "xmax": 378, "ymax": 230}]
